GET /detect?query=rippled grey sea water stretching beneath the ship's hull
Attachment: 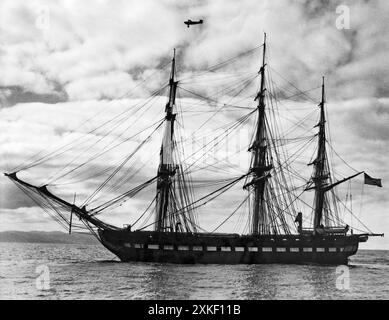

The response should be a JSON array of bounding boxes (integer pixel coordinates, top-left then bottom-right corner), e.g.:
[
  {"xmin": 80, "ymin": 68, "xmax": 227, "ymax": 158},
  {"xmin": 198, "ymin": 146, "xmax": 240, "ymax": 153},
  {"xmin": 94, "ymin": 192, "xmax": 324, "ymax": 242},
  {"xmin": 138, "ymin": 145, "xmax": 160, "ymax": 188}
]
[{"xmin": 0, "ymin": 243, "xmax": 389, "ymax": 299}]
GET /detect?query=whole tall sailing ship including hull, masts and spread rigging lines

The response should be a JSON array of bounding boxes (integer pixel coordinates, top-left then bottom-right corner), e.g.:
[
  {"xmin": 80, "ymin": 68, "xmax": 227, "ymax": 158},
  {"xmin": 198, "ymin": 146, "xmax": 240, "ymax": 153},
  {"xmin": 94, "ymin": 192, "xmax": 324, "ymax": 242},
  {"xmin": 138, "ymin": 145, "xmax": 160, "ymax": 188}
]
[{"xmin": 5, "ymin": 35, "xmax": 382, "ymax": 264}]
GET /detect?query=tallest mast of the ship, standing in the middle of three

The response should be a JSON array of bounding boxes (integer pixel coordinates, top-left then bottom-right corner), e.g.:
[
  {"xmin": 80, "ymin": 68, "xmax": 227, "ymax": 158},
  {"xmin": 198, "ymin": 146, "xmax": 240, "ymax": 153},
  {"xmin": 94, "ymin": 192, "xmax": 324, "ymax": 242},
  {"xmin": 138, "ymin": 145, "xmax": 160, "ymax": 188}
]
[{"xmin": 245, "ymin": 33, "xmax": 272, "ymax": 234}]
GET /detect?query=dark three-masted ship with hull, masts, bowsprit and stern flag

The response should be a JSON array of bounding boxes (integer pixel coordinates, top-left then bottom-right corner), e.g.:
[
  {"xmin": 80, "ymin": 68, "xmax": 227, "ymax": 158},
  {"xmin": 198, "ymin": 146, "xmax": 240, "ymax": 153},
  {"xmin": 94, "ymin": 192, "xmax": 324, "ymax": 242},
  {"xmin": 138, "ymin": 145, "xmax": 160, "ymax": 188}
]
[{"xmin": 6, "ymin": 36, "xmax": 381, "ymax": 264}]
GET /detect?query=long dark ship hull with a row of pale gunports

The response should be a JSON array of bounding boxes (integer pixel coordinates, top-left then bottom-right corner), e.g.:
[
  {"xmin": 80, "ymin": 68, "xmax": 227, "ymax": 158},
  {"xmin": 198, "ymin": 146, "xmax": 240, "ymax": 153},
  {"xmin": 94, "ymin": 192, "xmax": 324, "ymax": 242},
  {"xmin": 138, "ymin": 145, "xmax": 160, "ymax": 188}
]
[{"xmin": 99, "ymin": 230, "xmax": 367, "ymax": 265}]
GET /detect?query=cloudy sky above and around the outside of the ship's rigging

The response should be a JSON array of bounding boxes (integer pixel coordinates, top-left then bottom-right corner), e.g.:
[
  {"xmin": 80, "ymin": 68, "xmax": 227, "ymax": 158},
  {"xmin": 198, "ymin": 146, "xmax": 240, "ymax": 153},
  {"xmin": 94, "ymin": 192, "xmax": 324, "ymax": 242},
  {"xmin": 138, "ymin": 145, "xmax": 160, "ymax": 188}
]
[{"xmin": 0, "ymin": 0, "xmax": 389, "ymax": 249}]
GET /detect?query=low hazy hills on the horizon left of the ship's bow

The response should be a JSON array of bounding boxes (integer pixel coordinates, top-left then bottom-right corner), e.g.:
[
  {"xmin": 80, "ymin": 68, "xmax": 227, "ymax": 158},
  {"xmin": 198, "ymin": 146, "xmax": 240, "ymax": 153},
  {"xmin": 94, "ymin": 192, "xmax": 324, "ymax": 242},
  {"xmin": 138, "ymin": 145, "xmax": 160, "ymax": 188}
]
[{"xmin": 0, "ymin": 231, "xmax": 98, "ymax": 244}]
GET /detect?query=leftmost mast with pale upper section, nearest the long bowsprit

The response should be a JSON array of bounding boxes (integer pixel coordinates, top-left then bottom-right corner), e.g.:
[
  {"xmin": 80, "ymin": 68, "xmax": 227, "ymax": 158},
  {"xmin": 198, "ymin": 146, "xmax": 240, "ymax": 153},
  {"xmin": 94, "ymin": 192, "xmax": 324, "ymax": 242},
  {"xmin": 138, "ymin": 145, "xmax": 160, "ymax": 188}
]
[{"xmin": 155, "ymin": 49, "xmax": 178, "ymax": 231}]
